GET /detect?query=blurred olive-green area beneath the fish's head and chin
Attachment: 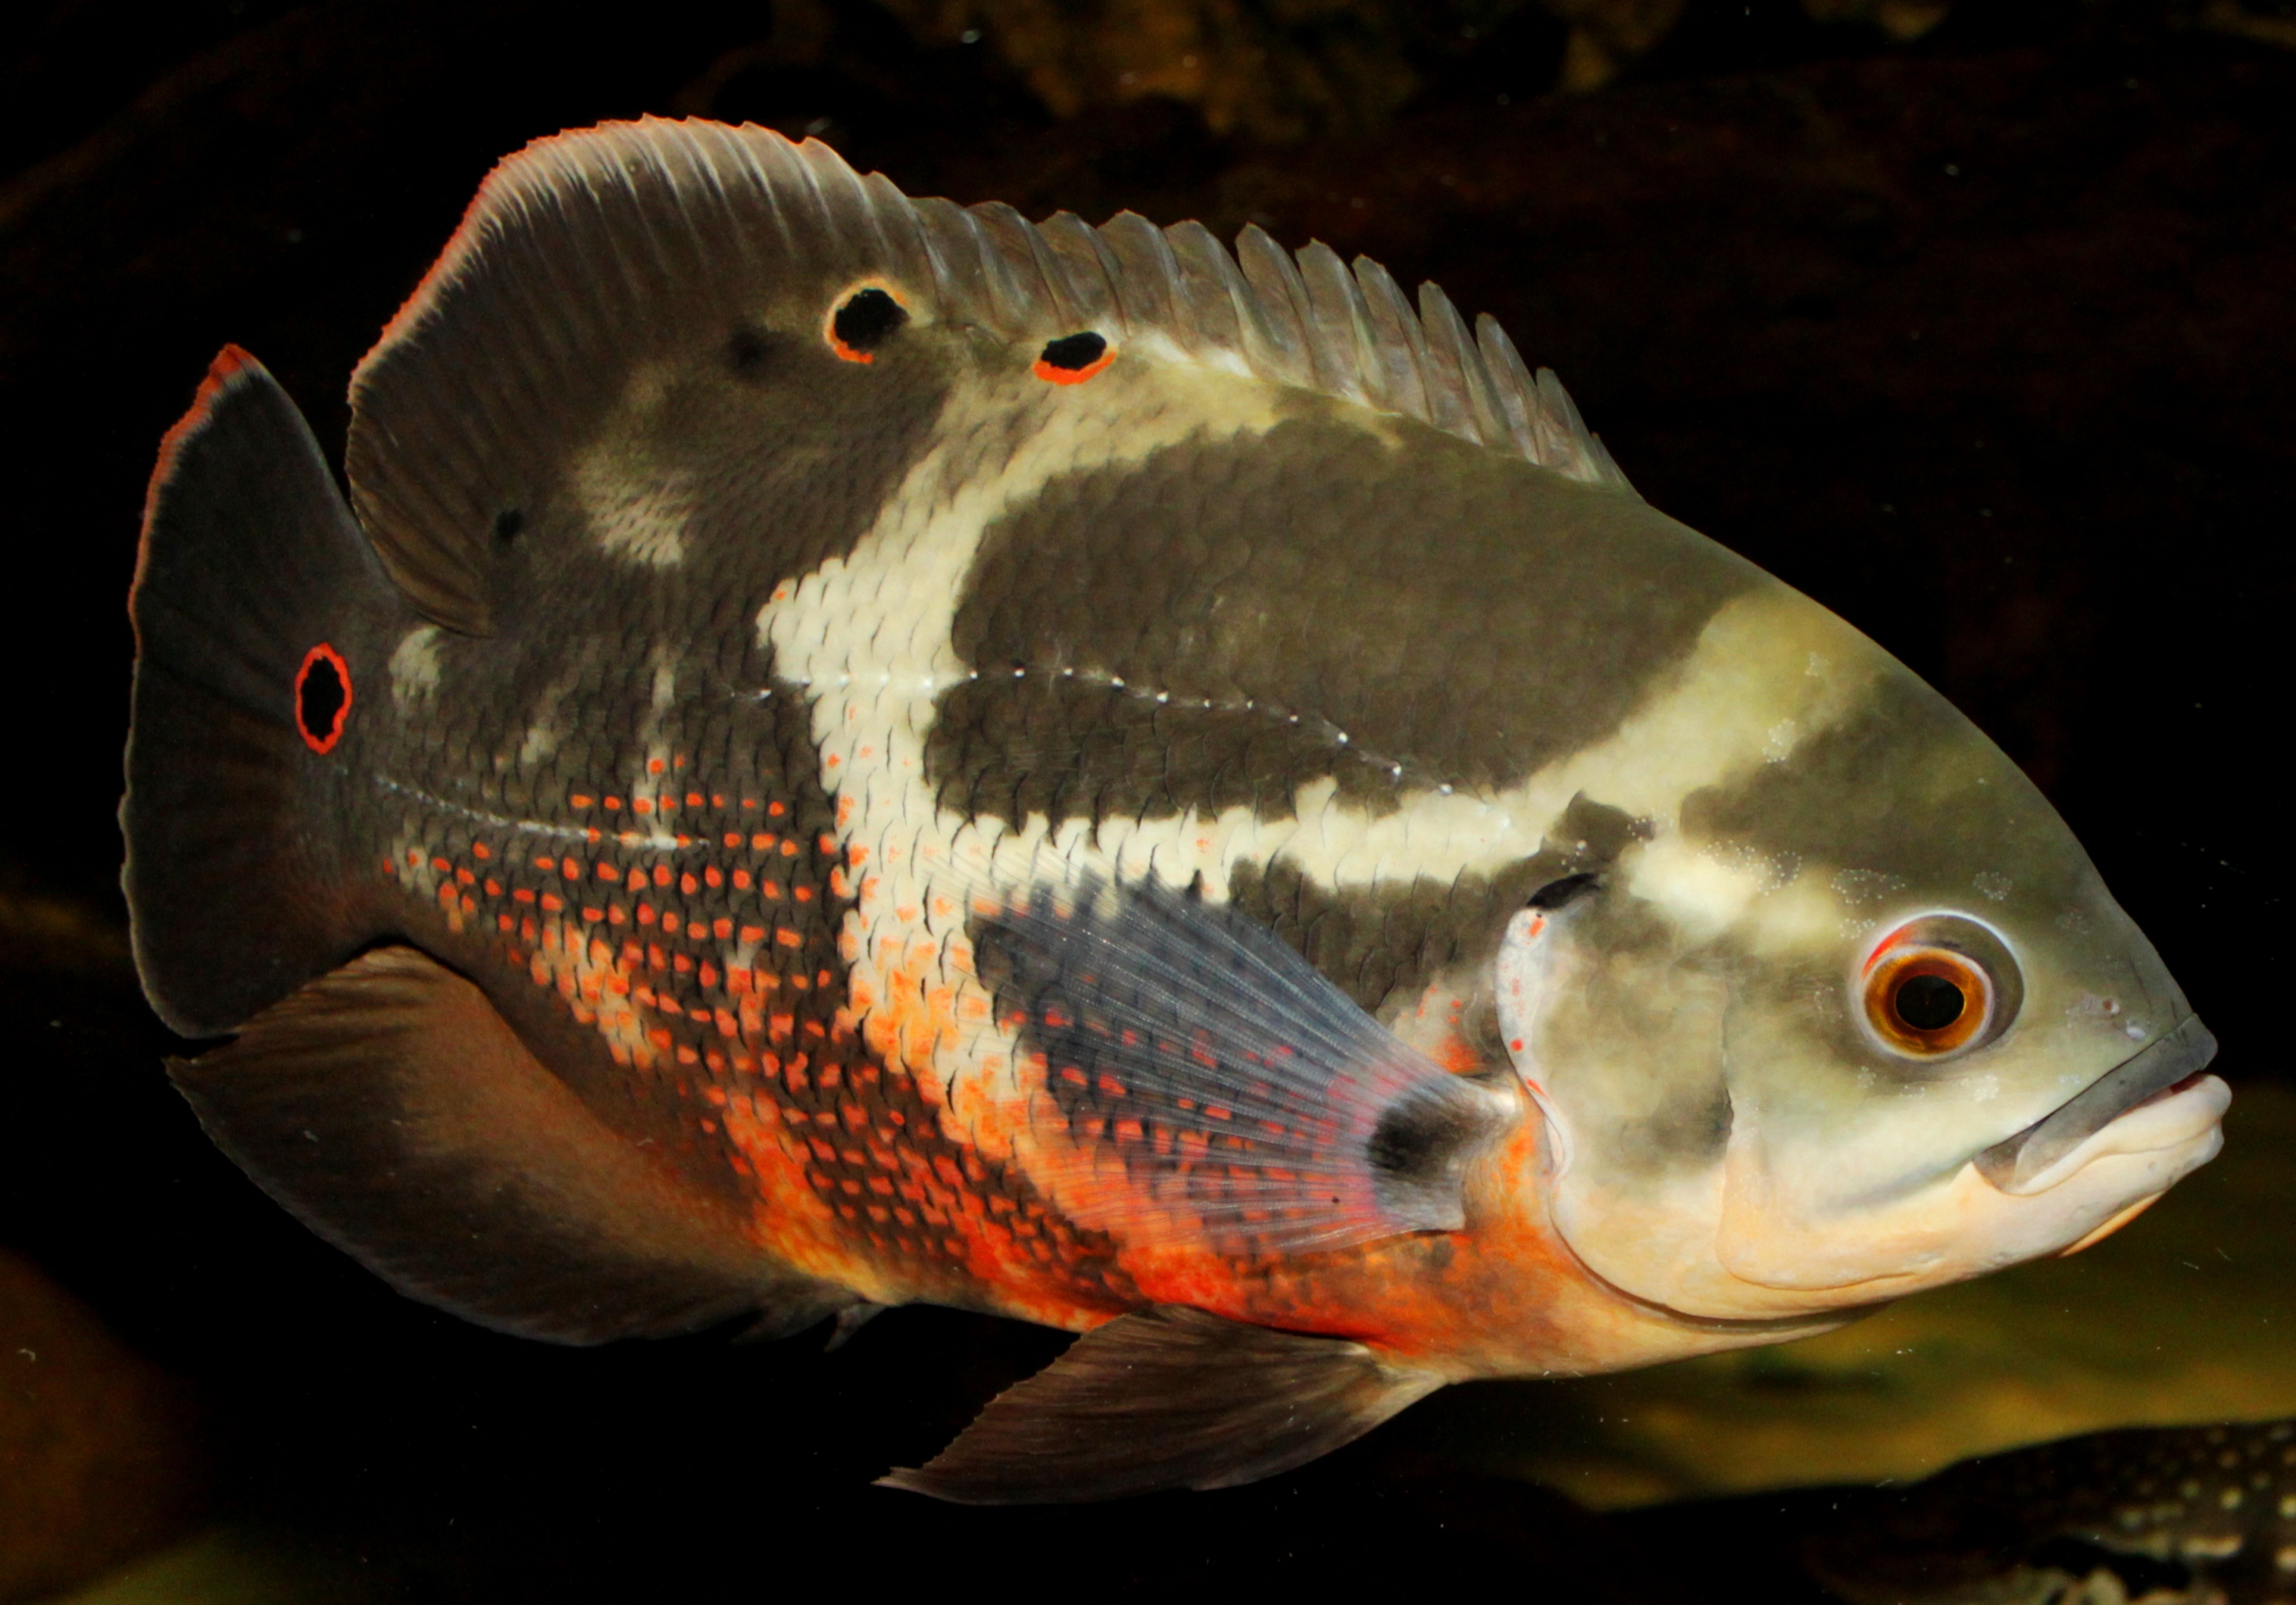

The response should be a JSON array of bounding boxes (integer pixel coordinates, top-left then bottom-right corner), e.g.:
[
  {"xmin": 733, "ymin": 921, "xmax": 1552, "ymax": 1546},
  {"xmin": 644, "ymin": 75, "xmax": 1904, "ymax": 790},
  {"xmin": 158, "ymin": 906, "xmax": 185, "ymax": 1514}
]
[{"xmin": 1405, "ymin": 1086, "xmax": 2296, "ymax": 1508}]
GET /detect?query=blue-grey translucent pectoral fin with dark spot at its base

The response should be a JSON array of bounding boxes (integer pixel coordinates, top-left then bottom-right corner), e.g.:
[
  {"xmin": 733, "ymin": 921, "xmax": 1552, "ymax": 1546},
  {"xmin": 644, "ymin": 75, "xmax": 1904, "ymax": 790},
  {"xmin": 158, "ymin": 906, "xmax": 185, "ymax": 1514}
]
[{"xmin": 973, "ymin": 881, "xmax": 1518, "ymax": 1254}]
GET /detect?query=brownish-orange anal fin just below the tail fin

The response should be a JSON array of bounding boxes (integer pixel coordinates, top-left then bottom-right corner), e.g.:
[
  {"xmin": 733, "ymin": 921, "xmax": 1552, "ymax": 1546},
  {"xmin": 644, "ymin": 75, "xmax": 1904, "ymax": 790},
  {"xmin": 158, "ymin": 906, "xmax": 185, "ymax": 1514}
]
[{"xmin": 168, "ymin": 949, "xmax": 852, "ymax": 1343}]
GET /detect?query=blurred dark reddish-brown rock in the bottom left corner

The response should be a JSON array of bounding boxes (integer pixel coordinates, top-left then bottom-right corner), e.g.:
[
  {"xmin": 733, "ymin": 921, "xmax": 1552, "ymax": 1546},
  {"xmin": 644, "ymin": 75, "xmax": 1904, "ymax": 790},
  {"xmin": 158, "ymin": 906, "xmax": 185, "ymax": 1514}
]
[{"xmin": 0, "ymin": 1249, "xmax": 204, "ymax": 1601}]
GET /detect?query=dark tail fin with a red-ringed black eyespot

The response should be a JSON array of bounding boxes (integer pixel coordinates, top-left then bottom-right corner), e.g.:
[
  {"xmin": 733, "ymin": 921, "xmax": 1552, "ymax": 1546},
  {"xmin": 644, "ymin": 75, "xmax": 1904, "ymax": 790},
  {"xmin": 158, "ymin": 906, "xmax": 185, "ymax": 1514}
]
[{"xmin": 119, "ymin": 347, "xmax": 411, "ymax": 1036}]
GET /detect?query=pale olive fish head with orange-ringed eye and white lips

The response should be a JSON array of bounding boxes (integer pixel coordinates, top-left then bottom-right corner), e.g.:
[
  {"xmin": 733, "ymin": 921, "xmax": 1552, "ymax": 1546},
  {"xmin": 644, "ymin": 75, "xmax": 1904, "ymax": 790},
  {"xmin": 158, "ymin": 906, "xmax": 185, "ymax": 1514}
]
[{"xmin": 1492, "ymin": 586, "xmax": 2230, "ymax": 1320}]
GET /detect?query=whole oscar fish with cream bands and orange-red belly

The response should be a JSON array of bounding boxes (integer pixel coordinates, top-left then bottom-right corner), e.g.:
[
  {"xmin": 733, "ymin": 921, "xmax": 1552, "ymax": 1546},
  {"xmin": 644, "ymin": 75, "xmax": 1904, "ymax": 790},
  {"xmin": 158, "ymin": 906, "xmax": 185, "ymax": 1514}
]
[{"xmin": 122, "ymin": 119, "xmax": 2227, "ymax": 1502}]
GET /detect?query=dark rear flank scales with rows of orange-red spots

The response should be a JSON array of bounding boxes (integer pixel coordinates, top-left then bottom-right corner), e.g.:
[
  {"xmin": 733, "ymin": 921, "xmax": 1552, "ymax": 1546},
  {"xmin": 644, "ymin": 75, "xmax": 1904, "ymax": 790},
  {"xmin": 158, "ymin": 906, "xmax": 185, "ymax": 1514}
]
[{"xmin": 371, "ymin": 638, "xmax": 1120, "ymax": 1306}]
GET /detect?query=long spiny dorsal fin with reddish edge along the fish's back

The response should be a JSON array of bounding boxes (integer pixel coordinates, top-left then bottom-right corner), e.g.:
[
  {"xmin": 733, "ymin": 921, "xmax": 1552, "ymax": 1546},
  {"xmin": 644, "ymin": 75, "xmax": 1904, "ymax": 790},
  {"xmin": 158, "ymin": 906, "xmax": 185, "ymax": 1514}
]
[{"xmin": 349, "ymin": 119, "xmax": 1631, "ymax": 634}]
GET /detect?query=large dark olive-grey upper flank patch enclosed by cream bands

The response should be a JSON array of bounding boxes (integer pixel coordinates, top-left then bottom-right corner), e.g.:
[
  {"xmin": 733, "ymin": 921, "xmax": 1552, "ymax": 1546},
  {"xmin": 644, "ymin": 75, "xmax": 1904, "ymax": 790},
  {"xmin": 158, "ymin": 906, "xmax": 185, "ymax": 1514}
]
[{"xmin": 926, "ymin": 402, "xmax": 1759, "ymax": 822}]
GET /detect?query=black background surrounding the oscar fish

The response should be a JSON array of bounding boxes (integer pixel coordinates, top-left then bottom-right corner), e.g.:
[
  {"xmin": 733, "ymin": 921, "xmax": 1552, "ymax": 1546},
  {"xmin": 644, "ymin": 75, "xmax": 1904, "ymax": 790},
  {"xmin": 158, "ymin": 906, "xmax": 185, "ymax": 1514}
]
[{"xmin": 0, "ymin": 0, "xmax": 2296, "ymax": 1601}]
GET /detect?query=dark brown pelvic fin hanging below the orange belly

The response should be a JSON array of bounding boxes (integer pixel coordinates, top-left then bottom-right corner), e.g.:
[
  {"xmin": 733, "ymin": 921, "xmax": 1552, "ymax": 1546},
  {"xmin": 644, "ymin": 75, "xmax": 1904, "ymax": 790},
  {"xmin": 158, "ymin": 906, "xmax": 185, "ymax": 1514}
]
[{"xmin": 882, "ymin": 1306, "xmax": 1442, "ymax": 1504}]
